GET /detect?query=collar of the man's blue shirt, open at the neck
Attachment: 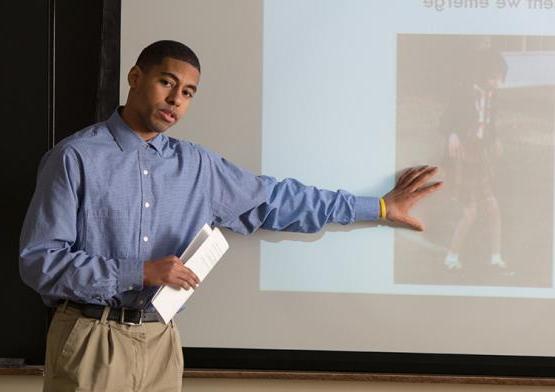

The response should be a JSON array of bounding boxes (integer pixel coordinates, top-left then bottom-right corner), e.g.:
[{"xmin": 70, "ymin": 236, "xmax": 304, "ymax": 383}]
[{"xmin": 106, "ymin": 107, "xmax": 167, "ymax": 156}]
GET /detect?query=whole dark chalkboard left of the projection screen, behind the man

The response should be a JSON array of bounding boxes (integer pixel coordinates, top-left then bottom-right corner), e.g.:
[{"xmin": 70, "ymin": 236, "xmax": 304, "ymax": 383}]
[{"xmin": 0, "ymin": 0, "xmax": 120, "ymax": 365}]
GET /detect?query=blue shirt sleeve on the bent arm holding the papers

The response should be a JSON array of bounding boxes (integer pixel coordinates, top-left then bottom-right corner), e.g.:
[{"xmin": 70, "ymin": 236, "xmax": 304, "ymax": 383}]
[{"xmin": 19, "ymin": 146, "xmax": 143, "ymax": 304}]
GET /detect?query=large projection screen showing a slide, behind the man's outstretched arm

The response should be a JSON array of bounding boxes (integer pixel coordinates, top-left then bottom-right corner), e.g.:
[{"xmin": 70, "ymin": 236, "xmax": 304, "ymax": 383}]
[{"xmin": 120, "ymin": 0, "xmax": 555, "ymax": 362}]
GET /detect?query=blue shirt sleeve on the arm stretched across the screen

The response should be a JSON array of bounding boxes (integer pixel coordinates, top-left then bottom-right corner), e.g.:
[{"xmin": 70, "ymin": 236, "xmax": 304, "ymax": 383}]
[{"xmin": 205, "ymin": 149, "xmax": 379, "ymax": 234}]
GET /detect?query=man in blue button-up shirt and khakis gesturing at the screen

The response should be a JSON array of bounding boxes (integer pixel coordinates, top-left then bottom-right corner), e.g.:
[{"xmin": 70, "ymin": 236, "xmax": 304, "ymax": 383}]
[{"xmin": 20, "ymin": 41, "xmax": 440, "ymax": 392}]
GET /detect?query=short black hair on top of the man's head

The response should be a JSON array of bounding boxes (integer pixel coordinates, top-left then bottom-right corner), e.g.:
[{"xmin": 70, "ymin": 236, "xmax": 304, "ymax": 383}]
[{"xmin": 135, "ymin": 40, "xmax": 200, "ymax": 72}]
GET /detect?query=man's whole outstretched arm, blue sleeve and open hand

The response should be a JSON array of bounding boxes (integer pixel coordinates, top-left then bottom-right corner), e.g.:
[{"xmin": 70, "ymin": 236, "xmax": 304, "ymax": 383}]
[{"xmin": 204, "ymin": 143, "xmax": 441, "ymax": 234}]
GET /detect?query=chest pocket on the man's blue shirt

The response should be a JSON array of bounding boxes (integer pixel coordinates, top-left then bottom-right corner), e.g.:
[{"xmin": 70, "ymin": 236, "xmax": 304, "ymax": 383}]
[{"xmin": 85, "ymin": 208, "xmax": 131, "ymax": 258}]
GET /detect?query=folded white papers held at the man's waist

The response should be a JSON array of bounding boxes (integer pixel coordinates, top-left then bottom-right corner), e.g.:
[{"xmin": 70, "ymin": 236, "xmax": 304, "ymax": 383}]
[{"xmin": 152, "ymin": 225, "xmax": 229, "ymax": 324}]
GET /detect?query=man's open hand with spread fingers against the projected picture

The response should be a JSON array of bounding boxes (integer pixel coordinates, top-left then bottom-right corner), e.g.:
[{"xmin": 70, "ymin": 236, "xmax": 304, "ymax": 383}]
[{"xmin": 383, "ymin": 166, "xmax": 442, "ymax": 231}]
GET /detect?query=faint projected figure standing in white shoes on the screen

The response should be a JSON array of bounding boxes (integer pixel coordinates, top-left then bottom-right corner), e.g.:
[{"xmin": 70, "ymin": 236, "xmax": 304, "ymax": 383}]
[{"xmin": 441, "ymin": 49, "xmax": 507, "ymax": 270}]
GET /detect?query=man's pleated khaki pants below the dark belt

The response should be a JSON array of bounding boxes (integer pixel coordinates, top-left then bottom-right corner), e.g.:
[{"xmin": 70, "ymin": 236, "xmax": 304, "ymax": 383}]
[{"xmin": 43, "ymin": 305, "xmax": 183, "ymax": 392}]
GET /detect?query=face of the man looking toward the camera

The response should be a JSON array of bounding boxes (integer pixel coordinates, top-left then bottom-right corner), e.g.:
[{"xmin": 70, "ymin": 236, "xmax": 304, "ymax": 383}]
[{"xmin": 124, "ymin": 57, "xmax": 200, "ymax": 138}]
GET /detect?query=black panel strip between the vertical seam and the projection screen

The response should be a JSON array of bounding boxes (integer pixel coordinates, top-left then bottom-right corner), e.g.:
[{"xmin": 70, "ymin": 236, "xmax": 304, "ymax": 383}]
[{"xmin": 54, "ymin": 0, "xmax": 121, "ymax": 142}]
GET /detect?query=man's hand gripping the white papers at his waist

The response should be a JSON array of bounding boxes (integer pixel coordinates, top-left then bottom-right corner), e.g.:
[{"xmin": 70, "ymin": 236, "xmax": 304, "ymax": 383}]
[{"xmin": 143, "ymin": 256, "xmax": 200, "ymax": 290}]
